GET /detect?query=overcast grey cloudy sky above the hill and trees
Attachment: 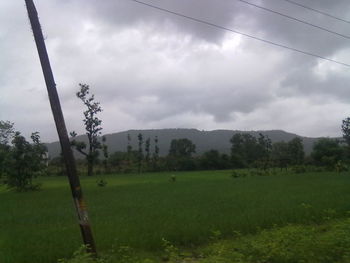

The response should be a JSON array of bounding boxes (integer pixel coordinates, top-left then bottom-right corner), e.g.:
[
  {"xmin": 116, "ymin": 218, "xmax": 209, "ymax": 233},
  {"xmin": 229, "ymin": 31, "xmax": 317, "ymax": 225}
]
[{"xmin": 0, "ymin": 0, "xmax": 350, "ymax": 141}]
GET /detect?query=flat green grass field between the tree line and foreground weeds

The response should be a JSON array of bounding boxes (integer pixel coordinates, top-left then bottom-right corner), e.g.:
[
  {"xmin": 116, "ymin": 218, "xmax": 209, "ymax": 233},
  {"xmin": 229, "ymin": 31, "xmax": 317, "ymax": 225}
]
[{"xmin": 0, "ymin": 171, "xmax": 350, "ymax": 263}]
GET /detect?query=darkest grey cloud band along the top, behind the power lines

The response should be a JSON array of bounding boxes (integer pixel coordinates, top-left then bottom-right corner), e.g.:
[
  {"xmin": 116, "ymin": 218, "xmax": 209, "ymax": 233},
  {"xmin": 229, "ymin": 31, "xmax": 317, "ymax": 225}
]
[{"xmin": 73, "ymin": 0, "xmax": 350, "ymax": 56}]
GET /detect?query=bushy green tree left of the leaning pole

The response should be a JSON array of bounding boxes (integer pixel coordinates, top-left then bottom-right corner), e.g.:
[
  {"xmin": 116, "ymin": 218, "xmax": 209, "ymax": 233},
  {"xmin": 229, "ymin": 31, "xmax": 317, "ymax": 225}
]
[{"xmin": 6, "ymin": 132, "xmax": 47, "ymax": 191}]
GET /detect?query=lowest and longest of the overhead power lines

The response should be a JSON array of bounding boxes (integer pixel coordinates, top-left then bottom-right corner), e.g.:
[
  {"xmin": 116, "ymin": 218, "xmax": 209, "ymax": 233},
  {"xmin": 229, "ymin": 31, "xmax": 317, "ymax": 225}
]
[{"xmin": 129, "ymin": 0, "xmax": 350, "ymax": 67}]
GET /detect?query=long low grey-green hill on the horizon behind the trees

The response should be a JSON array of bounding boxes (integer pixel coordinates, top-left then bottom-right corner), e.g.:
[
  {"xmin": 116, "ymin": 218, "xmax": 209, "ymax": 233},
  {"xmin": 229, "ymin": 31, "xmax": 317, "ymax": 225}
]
[{"xmin": 46, "ymin": 129, "xmax": 326, "ymax": 158}]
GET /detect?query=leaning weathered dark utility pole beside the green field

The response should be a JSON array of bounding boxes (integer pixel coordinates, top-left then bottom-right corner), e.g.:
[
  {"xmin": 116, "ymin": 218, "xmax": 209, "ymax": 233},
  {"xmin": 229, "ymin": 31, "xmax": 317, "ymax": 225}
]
[{"xmin": 25, "ymin": 0, "xmax": 96, "ymax": 255}]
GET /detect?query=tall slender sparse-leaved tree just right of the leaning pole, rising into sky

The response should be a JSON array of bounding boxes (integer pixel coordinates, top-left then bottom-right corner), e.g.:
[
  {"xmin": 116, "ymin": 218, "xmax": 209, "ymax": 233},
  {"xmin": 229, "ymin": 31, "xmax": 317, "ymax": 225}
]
[{"xmin": 71, "ymin": 84, "xmax": 102, "ymax": 176}]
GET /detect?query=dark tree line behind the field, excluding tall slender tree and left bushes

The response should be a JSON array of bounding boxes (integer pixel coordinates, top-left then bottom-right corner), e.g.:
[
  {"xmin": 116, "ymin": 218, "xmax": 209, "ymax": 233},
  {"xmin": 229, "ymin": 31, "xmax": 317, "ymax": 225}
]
[{"xmin": 51, "ymin": 129, "xmax": 349, "ymax": 174}]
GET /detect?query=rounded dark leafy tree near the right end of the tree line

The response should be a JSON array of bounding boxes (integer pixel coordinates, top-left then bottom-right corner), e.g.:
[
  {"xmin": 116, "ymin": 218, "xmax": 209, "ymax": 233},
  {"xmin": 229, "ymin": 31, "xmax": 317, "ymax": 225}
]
[{"xmin": 311, "ymin": 138, "xmax": 344, "ymax": 168}]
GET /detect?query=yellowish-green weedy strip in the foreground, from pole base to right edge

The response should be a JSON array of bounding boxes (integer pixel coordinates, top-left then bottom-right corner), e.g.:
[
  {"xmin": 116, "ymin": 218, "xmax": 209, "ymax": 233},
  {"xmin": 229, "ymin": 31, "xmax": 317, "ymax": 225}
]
[{"xmin": 59, "ymin": 218, "xmax": 350, "ymax": 263}]
